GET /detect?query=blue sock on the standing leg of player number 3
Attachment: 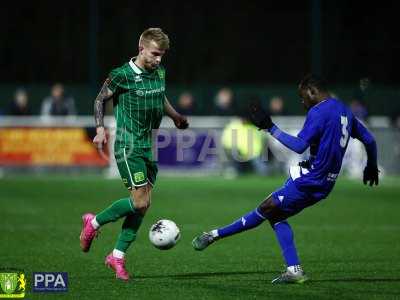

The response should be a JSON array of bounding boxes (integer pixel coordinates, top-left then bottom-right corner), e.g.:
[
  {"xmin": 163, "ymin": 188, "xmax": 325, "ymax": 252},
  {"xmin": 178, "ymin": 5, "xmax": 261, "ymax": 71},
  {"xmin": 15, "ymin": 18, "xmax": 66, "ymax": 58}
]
[{"xmin": 272, "ymin": 221, "xmax": 300, "ymax": 267}]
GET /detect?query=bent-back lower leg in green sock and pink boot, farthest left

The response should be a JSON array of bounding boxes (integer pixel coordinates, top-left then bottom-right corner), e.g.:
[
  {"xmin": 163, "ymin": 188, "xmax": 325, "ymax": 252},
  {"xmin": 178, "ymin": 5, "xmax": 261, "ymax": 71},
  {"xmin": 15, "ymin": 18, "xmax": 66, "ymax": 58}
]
[{"xmin": 79, "ymin": 198, "xmax": 135, "ymax": 252}]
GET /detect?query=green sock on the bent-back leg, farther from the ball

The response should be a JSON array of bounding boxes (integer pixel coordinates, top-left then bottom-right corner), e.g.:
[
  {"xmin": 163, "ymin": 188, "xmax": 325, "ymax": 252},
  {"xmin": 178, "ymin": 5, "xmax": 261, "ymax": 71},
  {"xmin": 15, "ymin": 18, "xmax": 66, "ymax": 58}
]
[{"xmin": 96, "ymin": 198, "xmax": 137, "ymax": 226}]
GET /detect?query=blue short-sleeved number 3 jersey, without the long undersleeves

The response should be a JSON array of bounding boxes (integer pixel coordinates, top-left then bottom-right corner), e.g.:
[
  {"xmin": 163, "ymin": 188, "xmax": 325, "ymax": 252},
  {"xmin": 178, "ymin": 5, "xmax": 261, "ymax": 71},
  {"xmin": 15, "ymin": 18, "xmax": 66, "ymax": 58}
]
[{"xmin": 290, "ymin": 98, "xmax": 360, "ymax": 199}]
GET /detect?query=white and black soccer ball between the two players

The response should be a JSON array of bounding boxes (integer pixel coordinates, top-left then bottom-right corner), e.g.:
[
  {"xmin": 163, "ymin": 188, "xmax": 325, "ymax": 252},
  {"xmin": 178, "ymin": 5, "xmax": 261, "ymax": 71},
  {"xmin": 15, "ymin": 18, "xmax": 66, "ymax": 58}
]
[{"xmin": 149, "ymin": 220, "xmax": 181, "ymax": 250}]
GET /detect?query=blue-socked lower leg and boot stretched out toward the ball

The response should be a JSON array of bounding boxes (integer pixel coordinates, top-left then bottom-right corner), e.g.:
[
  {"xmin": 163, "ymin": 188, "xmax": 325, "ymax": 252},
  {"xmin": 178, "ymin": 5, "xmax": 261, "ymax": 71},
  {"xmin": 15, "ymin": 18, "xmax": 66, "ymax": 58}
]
[{"xmin": 192, "ymin": 208, "xmax": 265, "ymax": 251}]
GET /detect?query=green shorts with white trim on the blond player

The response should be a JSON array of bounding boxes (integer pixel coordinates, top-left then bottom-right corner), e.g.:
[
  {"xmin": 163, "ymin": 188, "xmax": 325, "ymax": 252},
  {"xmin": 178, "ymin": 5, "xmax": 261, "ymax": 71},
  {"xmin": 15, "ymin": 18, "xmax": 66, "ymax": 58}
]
[{"xmin": 114, "ymin": 147, "xmax": 158, "ymax": 189}]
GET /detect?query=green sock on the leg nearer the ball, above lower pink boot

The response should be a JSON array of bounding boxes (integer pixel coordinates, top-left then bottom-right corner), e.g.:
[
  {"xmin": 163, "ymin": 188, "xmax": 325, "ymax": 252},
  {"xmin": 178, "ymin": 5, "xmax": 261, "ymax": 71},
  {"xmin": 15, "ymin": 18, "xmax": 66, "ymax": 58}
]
[{"xmin": 115, "ymin": 213, "xmax": 143, "ymax": 253}]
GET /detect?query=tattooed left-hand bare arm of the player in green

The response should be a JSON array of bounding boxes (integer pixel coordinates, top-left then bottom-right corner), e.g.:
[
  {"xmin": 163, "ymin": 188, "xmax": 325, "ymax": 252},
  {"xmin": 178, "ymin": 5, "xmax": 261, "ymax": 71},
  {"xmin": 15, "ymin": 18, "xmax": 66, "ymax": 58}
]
[{"xmin": 93, "ymin": 78, "xmax": 113, "ymax": 148}]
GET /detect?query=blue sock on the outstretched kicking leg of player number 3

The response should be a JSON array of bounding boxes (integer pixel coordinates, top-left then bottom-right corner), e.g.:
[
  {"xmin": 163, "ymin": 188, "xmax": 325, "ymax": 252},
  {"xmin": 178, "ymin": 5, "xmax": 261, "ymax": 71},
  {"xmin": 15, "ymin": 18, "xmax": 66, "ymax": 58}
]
[{"xmin": 218, "ymin": 208, "xmax": 265, "ymax": 238}]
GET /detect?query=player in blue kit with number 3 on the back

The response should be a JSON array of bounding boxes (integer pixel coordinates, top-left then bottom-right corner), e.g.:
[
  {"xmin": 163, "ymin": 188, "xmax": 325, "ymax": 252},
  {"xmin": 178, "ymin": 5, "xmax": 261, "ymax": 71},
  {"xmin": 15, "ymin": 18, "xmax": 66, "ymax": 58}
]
[{"xmin": 192, "ymin": 75, "xmax": 379, "ymax": 283}]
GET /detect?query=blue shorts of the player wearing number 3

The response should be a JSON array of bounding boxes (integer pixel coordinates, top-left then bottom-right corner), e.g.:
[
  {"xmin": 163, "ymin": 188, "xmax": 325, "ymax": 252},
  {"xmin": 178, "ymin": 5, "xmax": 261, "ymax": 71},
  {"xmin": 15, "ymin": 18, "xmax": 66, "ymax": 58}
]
[{"xmin": 272, "ymin": 178, "xmax": 321, "ymax": 217}]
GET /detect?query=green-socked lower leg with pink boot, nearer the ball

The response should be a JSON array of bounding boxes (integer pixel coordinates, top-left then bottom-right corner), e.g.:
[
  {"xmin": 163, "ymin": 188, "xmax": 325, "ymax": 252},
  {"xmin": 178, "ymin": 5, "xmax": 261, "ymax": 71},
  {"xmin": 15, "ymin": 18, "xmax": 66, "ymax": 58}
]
[{"xmin": 105, "ymin": 212, "xmax": 143, "ymax": 280}]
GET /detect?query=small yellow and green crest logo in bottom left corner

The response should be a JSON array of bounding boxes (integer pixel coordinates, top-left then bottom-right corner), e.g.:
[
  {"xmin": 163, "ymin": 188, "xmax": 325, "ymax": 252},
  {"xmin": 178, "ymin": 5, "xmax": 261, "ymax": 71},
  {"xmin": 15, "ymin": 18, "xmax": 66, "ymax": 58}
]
[{"xmin": 0, "ymin": 272, "xmax": 26, "ymax": 298}]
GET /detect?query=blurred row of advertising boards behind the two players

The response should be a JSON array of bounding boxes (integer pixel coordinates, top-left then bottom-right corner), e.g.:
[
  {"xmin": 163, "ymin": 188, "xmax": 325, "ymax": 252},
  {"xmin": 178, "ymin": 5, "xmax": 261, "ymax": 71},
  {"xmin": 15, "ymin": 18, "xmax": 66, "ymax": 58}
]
[{"xmin": 0, "ymin": 116, "xmax": 400, "ymax": 178}]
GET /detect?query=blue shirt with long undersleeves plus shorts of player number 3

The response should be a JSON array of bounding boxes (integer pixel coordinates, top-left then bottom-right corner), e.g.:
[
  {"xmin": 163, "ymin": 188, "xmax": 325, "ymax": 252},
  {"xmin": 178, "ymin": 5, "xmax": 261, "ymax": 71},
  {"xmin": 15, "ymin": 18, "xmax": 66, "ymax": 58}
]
[{"xmin": 268, "ymin": 98, "xmax": 377, "ymax": 216}]
